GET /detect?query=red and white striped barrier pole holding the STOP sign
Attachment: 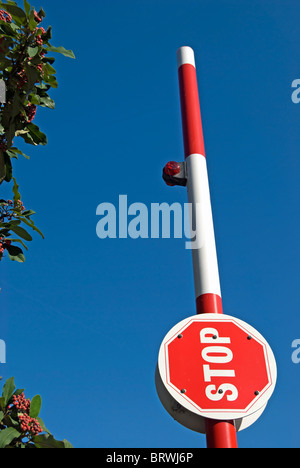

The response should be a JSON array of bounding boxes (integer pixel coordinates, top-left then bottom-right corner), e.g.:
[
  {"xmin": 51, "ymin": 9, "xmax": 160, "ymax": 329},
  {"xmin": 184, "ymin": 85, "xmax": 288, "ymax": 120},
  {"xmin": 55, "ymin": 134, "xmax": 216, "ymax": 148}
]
[{"xmin": 177, "ymin": 47, "xmax": 237, "ymax": 448}]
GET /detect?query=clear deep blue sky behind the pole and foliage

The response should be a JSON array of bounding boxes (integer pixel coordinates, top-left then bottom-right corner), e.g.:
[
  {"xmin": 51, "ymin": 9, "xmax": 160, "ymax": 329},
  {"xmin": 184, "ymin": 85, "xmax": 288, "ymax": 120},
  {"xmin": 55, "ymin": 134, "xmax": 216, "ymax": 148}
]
[{"xmin": 0, "ymin": 0, "xmax": 300, "ymax": 448}]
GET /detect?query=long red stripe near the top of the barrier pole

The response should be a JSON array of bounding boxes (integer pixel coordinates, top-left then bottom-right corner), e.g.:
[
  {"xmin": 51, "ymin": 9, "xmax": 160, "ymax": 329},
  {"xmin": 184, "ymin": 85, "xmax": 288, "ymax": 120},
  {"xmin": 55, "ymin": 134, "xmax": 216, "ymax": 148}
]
[{"xmin": 178, "ymin": 63, "xmax": 205, "ymax": 158}]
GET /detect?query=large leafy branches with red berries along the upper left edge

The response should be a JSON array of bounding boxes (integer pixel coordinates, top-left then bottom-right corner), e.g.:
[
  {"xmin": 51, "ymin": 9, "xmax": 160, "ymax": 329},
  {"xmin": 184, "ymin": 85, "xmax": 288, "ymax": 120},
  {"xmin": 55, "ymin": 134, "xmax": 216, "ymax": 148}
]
[{"xmin": 0, "ymin": 0, "xmax": 75, "ymax": 262}]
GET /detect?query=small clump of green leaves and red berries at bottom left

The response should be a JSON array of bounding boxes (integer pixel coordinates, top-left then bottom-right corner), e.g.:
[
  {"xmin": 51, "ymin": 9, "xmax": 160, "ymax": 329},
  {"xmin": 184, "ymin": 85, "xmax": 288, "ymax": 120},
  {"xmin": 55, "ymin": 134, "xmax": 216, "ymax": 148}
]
[{"xmin": 0, "ymin": 377, "xmax": 73, "ymax": 448}]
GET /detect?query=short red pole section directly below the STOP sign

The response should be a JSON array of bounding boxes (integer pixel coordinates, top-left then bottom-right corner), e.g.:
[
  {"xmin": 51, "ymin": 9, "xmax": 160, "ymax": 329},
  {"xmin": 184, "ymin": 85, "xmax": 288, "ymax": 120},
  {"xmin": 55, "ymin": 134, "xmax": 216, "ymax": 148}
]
[{"xmin": 206, "ymin": 419, "xmax": 238, "ymax": 448}]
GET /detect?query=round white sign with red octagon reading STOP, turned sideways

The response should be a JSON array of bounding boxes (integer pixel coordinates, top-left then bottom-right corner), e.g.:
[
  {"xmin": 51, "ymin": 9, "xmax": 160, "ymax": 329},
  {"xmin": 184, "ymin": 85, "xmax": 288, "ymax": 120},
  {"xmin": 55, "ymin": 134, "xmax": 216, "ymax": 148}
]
[{"xmin": 157, "ymin": 314, "xmax": 277, "ymax": 425}]
